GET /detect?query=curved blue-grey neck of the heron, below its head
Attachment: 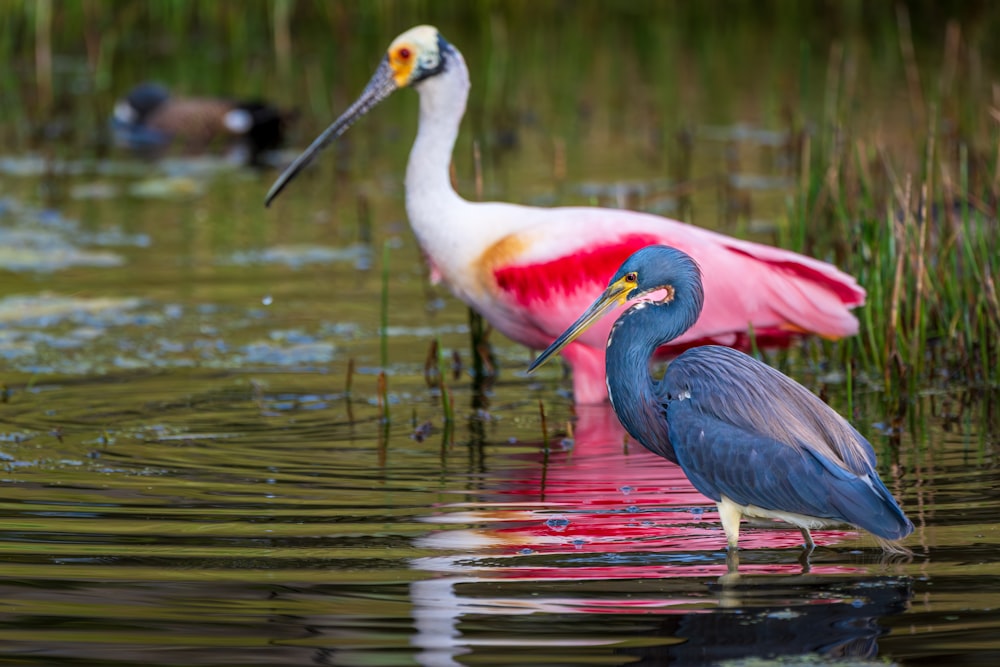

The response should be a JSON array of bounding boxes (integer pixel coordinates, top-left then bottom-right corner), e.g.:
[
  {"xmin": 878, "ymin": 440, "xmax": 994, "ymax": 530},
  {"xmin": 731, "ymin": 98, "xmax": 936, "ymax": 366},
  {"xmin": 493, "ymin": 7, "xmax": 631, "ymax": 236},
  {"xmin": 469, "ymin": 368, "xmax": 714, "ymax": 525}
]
[{"xmin": 606, "ymin": 284, "xmax": 702, "ymax": 463}]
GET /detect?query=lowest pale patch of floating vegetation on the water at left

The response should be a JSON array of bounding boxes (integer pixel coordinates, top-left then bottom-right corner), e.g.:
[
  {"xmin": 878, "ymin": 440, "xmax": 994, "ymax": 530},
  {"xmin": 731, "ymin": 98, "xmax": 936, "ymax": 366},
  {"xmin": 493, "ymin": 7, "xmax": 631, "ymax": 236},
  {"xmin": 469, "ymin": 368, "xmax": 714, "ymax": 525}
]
[{"xmin": 0, "ymin": 294, "xmax": 336, "ymax": 376}]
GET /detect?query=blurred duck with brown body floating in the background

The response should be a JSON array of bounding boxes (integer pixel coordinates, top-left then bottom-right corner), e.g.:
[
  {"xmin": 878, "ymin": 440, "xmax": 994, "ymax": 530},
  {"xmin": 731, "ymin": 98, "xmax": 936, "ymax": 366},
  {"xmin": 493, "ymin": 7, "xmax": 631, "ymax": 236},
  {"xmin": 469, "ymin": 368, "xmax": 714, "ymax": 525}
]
[{"xmin": 111, "ymin": 83, "xmax": 294, "ymax": 165}]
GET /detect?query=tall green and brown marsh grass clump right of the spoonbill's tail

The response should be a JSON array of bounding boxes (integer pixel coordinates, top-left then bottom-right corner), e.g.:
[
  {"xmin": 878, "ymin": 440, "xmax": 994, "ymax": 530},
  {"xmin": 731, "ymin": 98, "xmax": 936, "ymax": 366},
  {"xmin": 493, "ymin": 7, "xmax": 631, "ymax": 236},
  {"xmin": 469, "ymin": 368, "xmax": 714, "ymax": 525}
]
[{"xmin": 787, "ymin": 10, "xmax": 1000, "ymax": 424}]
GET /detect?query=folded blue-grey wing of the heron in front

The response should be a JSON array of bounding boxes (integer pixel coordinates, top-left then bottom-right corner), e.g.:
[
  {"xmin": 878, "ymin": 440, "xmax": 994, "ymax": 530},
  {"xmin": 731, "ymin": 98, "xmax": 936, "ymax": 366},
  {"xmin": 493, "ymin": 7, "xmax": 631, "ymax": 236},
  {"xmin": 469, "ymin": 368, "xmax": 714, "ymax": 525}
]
[{"xmin": 660, "ymin": 346, "xmax": 911, "ymax": 539}]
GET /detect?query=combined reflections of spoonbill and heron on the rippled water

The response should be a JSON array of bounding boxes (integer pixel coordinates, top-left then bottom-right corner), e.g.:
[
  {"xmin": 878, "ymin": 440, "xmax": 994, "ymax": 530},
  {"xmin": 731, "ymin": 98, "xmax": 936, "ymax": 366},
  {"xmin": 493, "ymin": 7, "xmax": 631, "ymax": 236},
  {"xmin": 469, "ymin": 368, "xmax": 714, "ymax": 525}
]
[{"xmin": 410, "ymin": 406, "xmax": 910, "ymax": 667}]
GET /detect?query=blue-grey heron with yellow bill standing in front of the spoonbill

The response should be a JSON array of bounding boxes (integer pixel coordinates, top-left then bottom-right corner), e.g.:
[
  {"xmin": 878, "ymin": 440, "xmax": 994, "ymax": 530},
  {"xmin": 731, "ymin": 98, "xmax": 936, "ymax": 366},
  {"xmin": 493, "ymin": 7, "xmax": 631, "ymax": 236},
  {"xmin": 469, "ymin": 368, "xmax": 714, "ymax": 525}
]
[{"xmin": 528, "ymin": 246, "xmax": 913, "ymax": 553}]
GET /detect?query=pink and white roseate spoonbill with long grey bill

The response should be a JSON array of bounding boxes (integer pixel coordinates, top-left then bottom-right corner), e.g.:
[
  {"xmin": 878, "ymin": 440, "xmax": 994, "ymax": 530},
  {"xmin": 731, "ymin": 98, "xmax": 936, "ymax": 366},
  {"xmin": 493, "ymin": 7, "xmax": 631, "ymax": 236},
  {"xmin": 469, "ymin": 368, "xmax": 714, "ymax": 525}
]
[{"xmin": 265, "ymin": 26, "xmax": 865, "ymax": 403}]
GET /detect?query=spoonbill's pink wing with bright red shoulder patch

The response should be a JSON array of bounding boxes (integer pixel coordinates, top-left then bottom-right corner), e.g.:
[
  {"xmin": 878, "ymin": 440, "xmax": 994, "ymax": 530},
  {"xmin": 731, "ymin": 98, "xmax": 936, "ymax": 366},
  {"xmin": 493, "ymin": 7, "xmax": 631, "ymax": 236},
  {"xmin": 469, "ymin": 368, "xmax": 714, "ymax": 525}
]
[{"xmin": 480, "ymin": 208, "xmax": 865, "ymax": 350}]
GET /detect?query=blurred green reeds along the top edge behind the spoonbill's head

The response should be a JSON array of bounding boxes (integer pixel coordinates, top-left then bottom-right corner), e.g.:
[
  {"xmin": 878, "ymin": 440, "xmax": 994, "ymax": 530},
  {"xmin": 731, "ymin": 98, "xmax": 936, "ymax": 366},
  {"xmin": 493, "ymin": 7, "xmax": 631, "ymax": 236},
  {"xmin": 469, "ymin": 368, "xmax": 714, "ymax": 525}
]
[{"xmin": 0, "ymin": 0, "xmax": 1000, "ymax": 167}]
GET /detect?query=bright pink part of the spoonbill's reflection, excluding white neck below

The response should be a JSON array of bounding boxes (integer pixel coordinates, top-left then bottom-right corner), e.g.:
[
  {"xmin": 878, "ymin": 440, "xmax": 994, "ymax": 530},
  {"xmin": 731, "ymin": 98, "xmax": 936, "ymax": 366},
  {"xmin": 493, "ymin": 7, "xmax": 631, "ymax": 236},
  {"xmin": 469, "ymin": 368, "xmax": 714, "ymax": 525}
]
[{"xmin": 421, "ymin": 406, "xmax": 856, "ymax": 579}]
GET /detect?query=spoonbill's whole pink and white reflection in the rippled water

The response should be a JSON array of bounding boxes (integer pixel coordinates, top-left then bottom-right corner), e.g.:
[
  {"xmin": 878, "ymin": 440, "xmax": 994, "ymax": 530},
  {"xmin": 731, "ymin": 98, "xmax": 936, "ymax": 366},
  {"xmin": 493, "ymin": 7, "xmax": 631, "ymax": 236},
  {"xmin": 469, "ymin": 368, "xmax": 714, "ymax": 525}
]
[{"xmin": 410, "ymin": 408, "xmax": 884, "ymax": 667}]
